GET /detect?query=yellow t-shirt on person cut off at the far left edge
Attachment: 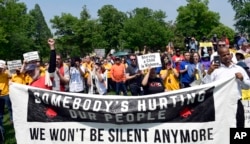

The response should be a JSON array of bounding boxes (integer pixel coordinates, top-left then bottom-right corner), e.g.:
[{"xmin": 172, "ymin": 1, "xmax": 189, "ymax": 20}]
[{"xmin": 0, "ymin": 71, "xmax": 9, "ymax": 96}]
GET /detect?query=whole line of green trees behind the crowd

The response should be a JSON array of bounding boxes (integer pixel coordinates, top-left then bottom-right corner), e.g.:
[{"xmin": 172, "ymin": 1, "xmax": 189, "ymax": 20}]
[{"xmin": 0, "ymin": 0, "xmax": 239, "ymax": 60}]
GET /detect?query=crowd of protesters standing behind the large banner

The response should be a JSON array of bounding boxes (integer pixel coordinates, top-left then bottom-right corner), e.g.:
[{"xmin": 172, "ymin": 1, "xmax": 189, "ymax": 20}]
[{"xmin": 0, "ymin": 34, "xmax": 250, "ymax": 141}]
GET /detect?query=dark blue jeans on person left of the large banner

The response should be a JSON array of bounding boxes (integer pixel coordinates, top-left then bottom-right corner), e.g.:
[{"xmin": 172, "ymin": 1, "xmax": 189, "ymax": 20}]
[{"xmin": 0, "ymin": 95, "xmax": 13, "ymax": 132}]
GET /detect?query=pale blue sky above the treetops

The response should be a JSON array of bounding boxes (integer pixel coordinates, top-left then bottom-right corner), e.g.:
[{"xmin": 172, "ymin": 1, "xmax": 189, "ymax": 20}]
[{"xmin": 19, "ymin": 0, "xmax": 235, "ymax": 31}]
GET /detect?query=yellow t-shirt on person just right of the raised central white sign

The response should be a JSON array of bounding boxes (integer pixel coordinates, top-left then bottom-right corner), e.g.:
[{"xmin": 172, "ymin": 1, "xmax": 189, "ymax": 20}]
[{"xmin": 160, "ymin": 69, "xmax": 180, "ymax": 91}]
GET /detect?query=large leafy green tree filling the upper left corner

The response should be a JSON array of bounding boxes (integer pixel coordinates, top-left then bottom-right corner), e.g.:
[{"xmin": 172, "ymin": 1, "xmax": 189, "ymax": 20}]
[{"xmin": 0, "ymin": 0, "xmax": 34, "ymax": 60}]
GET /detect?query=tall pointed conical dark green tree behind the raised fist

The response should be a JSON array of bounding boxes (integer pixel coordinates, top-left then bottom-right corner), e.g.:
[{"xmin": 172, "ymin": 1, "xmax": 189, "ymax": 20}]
[{"xmin": 29, "ymin": 4, "xmax": 52, "ymax": 60}]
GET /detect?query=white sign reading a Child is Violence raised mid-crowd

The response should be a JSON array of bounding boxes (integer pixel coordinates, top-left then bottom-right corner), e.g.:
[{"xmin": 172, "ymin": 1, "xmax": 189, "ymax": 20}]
[{"xmin": 137, "ymin": 53, "xmax": 162, "ymax": 70}]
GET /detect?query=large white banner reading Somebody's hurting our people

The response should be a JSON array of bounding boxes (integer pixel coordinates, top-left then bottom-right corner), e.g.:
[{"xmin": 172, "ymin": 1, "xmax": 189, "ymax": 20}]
[{"xmin": 10, "ymin": 78, "xmax": 244, "ymax": 144}]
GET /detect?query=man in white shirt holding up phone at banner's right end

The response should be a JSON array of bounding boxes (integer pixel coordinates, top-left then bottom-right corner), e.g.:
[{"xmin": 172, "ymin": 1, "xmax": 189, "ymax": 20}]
[{"xmin": 202, "ymin": 47, "xmax": 250, "ymax": 127}]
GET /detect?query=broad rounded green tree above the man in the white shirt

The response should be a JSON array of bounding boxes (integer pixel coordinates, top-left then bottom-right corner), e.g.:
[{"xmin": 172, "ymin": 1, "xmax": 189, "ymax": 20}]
[{"xmin": 176, "ymin": 0, "xmax": 220, "ymax": 39}]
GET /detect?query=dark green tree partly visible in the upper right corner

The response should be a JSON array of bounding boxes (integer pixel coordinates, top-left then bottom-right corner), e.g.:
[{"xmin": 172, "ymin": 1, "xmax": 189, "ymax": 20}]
[{"xmin": 228, "ymin": 0, "xmax": 250, "ymax": 33}]
